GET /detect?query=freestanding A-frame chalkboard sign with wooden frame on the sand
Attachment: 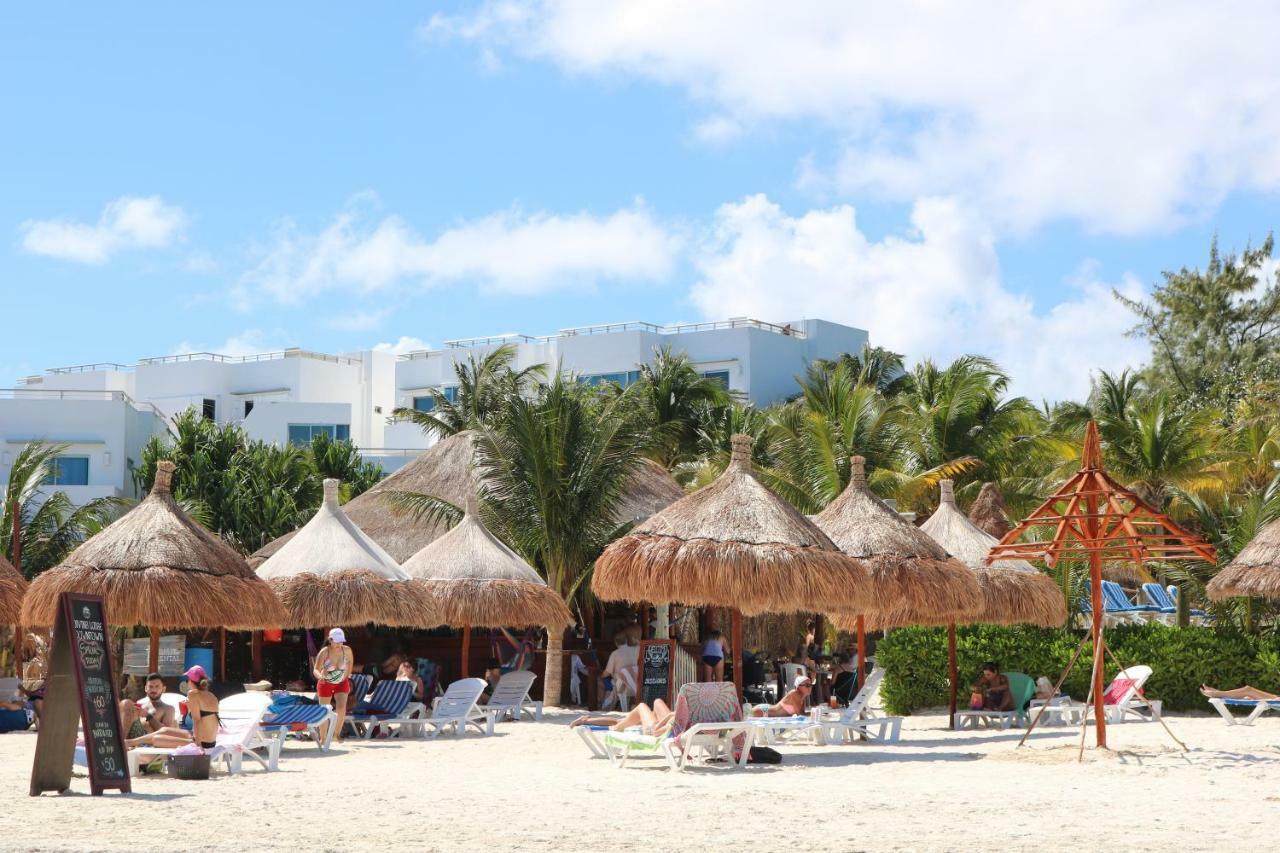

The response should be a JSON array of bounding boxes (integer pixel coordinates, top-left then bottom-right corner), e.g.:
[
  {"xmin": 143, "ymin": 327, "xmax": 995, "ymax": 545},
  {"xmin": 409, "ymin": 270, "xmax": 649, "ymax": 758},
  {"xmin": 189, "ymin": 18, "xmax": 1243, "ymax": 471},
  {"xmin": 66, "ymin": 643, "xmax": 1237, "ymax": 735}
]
[{"xmin": 31, "ymin": 593, "xmax": 132, "ymax": 797}]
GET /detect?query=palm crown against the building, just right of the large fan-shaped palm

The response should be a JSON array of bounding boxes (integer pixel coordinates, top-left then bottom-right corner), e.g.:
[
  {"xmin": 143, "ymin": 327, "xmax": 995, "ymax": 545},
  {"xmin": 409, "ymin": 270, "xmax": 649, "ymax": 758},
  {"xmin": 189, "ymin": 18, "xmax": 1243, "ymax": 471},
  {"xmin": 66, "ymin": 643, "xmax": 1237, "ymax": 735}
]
[{"xmin": 635, "ymin": 346, "xmax": 731, "ymax": 469}]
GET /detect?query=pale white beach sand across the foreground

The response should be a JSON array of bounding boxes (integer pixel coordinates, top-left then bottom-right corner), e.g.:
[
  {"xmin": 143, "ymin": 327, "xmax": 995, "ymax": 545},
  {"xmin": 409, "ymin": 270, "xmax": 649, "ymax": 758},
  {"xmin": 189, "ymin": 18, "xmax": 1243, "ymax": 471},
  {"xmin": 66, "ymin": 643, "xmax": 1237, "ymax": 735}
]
[{"xmin": 0, "ymin": 713, "xmax": 1280, "ymax": 850}]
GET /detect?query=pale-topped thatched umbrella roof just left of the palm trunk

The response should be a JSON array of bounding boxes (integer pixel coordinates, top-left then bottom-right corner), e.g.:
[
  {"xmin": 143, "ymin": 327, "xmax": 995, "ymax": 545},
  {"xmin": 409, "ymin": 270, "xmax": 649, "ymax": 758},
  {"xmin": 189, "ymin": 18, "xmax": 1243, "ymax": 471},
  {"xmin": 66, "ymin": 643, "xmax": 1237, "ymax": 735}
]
[{"xmin": 402, "ymin": 498, "xmax": 573, "ymax": 630}]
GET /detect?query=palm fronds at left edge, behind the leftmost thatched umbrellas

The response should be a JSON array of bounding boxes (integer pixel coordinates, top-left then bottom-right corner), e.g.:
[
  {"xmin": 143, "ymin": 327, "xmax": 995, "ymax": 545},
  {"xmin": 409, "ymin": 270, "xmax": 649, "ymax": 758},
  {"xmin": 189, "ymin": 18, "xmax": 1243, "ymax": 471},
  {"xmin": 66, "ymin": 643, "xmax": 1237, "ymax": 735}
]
[{"xmin": 0, "ymin": 441, "xmax": 128, "ymax": 578}]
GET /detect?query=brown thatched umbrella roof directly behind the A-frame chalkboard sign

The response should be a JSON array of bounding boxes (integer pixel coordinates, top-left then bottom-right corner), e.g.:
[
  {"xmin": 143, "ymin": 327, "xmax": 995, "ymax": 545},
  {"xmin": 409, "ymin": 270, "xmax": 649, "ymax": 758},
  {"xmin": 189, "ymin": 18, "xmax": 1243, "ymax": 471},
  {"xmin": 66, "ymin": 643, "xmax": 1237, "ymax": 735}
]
[{"xmin": 22, "ymin": 461, "xmax": 282, "ymax": 629}]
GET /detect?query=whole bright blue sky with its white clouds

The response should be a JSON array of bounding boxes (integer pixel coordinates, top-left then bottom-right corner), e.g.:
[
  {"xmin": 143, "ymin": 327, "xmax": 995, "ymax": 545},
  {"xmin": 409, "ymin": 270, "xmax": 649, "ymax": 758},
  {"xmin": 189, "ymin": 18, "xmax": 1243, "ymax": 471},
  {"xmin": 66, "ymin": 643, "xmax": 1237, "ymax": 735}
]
[{"xmin": 0, "ymin": 1, "xmax": 1280, "ymax": 397}]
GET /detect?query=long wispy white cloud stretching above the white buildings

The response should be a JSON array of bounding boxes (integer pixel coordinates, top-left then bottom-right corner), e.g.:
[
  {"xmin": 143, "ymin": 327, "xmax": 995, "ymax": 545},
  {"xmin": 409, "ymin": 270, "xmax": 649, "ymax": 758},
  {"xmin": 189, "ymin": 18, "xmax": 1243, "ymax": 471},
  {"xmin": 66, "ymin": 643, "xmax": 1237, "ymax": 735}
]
[{"xmin": 233, "ymin": 195, "xmax": 680, "ymax": 309}]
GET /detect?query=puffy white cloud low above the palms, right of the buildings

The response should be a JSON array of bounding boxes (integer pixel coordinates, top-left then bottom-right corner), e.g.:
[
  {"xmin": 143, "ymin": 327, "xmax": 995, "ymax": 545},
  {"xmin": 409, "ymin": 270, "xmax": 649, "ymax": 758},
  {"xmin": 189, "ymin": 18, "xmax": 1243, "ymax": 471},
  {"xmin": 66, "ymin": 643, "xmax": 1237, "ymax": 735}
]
[{"xmin": 691, "ymin": 196, "xmax": 1147, "ymax": 400}]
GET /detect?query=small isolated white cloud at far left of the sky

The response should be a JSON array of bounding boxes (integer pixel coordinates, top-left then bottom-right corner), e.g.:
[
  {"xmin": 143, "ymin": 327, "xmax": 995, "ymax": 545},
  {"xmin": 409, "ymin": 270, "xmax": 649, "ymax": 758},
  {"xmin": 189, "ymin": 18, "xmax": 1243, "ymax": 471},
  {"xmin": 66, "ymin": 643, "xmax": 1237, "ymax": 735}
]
[{"xmin": 20, "ymin": 196, "xmax": 187, "ymax": 264}]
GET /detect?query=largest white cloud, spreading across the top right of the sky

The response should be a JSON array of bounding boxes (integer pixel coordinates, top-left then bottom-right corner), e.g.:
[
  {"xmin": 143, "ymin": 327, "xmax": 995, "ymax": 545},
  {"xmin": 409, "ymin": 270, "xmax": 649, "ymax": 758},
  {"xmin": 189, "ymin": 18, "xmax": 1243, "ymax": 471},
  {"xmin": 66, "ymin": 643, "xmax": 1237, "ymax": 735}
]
[{"xmin": 432, "ymin": 0, "xmax": 1280, "ymax": 232}]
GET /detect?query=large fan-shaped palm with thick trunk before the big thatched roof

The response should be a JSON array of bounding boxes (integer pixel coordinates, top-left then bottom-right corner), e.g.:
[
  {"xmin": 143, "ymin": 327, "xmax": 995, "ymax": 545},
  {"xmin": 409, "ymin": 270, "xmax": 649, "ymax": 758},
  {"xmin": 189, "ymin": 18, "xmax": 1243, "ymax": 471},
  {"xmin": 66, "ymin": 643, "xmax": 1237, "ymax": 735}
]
[{"xmin": 476, "ymin": 373, "xmax": 652, "ymax": 702}]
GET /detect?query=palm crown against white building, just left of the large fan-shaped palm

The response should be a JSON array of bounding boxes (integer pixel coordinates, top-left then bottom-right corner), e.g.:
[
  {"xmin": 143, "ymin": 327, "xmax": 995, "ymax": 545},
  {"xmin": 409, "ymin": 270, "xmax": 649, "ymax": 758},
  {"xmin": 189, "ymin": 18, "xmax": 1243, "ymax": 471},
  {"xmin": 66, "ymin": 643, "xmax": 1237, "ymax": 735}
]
[{"xmin": 392, "ymin": 343, "xmax": 547, "ymax": 438}]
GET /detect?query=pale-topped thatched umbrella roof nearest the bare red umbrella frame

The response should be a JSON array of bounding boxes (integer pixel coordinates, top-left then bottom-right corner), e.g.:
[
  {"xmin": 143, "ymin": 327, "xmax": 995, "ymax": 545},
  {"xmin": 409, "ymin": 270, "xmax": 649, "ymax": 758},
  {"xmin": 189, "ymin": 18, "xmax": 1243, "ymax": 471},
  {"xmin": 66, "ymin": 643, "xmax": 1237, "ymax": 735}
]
[{"xmin": 920, "ymin": 480, "xmax": 1066, "ymax": 628}]
